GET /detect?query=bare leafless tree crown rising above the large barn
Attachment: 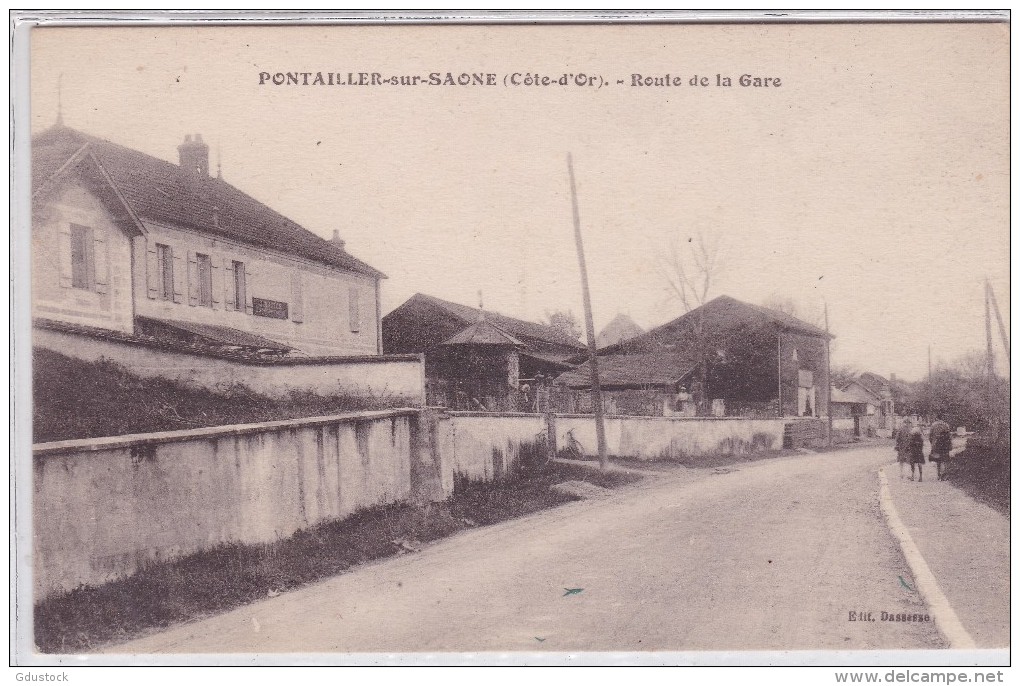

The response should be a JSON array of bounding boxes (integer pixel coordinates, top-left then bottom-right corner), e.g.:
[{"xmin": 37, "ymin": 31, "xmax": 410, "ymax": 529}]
[{"xmin": 659, "ymin": 231, "xmax": 725, "ymax": 312}]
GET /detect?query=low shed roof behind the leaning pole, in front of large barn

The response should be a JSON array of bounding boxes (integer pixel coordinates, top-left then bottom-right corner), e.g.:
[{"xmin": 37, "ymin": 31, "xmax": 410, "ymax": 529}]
[{"xmin": 555, "ymin": 352, "xmax": 697, "ymax": 388}]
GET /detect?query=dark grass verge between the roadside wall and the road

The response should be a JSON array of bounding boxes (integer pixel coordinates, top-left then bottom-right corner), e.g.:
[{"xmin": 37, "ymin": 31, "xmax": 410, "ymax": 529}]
[{"xmin": 35, "ymin": 456, "xmax": 640, "ymax": 653}]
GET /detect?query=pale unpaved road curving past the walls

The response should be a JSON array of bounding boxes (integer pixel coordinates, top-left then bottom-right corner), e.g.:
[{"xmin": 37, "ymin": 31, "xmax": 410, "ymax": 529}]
[{"xmin": 115, "ymin": 446, "xmax": 946, "ymax": 653}]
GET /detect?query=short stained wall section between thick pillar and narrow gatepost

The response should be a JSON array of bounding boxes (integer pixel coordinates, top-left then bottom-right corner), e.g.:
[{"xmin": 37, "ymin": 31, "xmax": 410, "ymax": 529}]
[{"xmin": 441, "ymin": 412, "xmax": 547, "ymax": 481}]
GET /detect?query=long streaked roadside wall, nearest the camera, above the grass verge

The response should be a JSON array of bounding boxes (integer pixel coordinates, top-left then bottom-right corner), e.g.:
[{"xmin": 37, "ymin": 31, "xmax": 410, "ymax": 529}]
[{"xmin": 33, "ymin": 409, "xmax": 434, "ymax": 598}]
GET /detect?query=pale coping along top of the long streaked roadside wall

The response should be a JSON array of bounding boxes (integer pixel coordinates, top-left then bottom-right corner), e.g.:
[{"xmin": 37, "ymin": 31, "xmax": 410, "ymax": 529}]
[{"xmin": 32, "ymin": 408, "xmax": 420, "ymax": 457}]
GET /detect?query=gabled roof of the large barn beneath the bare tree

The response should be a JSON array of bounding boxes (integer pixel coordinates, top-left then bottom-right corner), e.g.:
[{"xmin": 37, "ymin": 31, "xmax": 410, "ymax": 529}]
[{"xmin": 600, "ymin": 296, "xmax": 834, "ymax": 354}]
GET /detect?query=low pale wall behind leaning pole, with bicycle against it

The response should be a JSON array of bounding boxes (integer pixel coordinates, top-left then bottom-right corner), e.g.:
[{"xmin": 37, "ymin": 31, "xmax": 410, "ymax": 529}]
[{"xmin": 556, "ymin": 415, "xmax": 789, "ymax": 461}]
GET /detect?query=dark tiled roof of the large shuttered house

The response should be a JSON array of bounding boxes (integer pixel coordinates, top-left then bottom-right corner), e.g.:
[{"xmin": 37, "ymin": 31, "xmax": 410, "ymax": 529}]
[{"xmin": 32, "ymin": 125, "xmax": 385, "ymax": 278}]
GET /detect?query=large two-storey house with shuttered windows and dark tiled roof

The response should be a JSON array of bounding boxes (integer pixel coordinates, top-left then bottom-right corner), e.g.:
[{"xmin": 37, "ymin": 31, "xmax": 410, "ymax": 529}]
[{"xmin": 32, "ymin": 125, "xmax": 385, "ymax": 356}]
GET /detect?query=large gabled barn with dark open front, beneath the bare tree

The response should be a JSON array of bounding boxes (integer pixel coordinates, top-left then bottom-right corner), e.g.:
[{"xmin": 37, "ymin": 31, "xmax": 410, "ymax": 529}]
[{"xmin": 557, "ymin": 296, "xmax": 831, "ymax": 417}]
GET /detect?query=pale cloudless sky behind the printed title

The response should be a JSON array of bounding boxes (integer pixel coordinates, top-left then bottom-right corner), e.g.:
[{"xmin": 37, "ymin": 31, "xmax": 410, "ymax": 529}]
[{"xmin": 31, "ymin": 23, "xmax": 1010, "ymax": 379}]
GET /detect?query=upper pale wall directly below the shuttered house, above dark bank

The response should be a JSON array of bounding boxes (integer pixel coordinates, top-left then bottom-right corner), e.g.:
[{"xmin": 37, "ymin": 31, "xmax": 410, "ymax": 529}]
[{"xmin": 32, "ymin": 326, "xmax": 425, "ymax": 406}]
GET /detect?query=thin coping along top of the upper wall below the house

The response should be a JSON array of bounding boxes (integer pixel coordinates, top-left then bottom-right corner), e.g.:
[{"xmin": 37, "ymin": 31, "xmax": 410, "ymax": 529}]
[{"xmin": 32, "ymin": 317, "xmax": 424, "ymax": 367}]
